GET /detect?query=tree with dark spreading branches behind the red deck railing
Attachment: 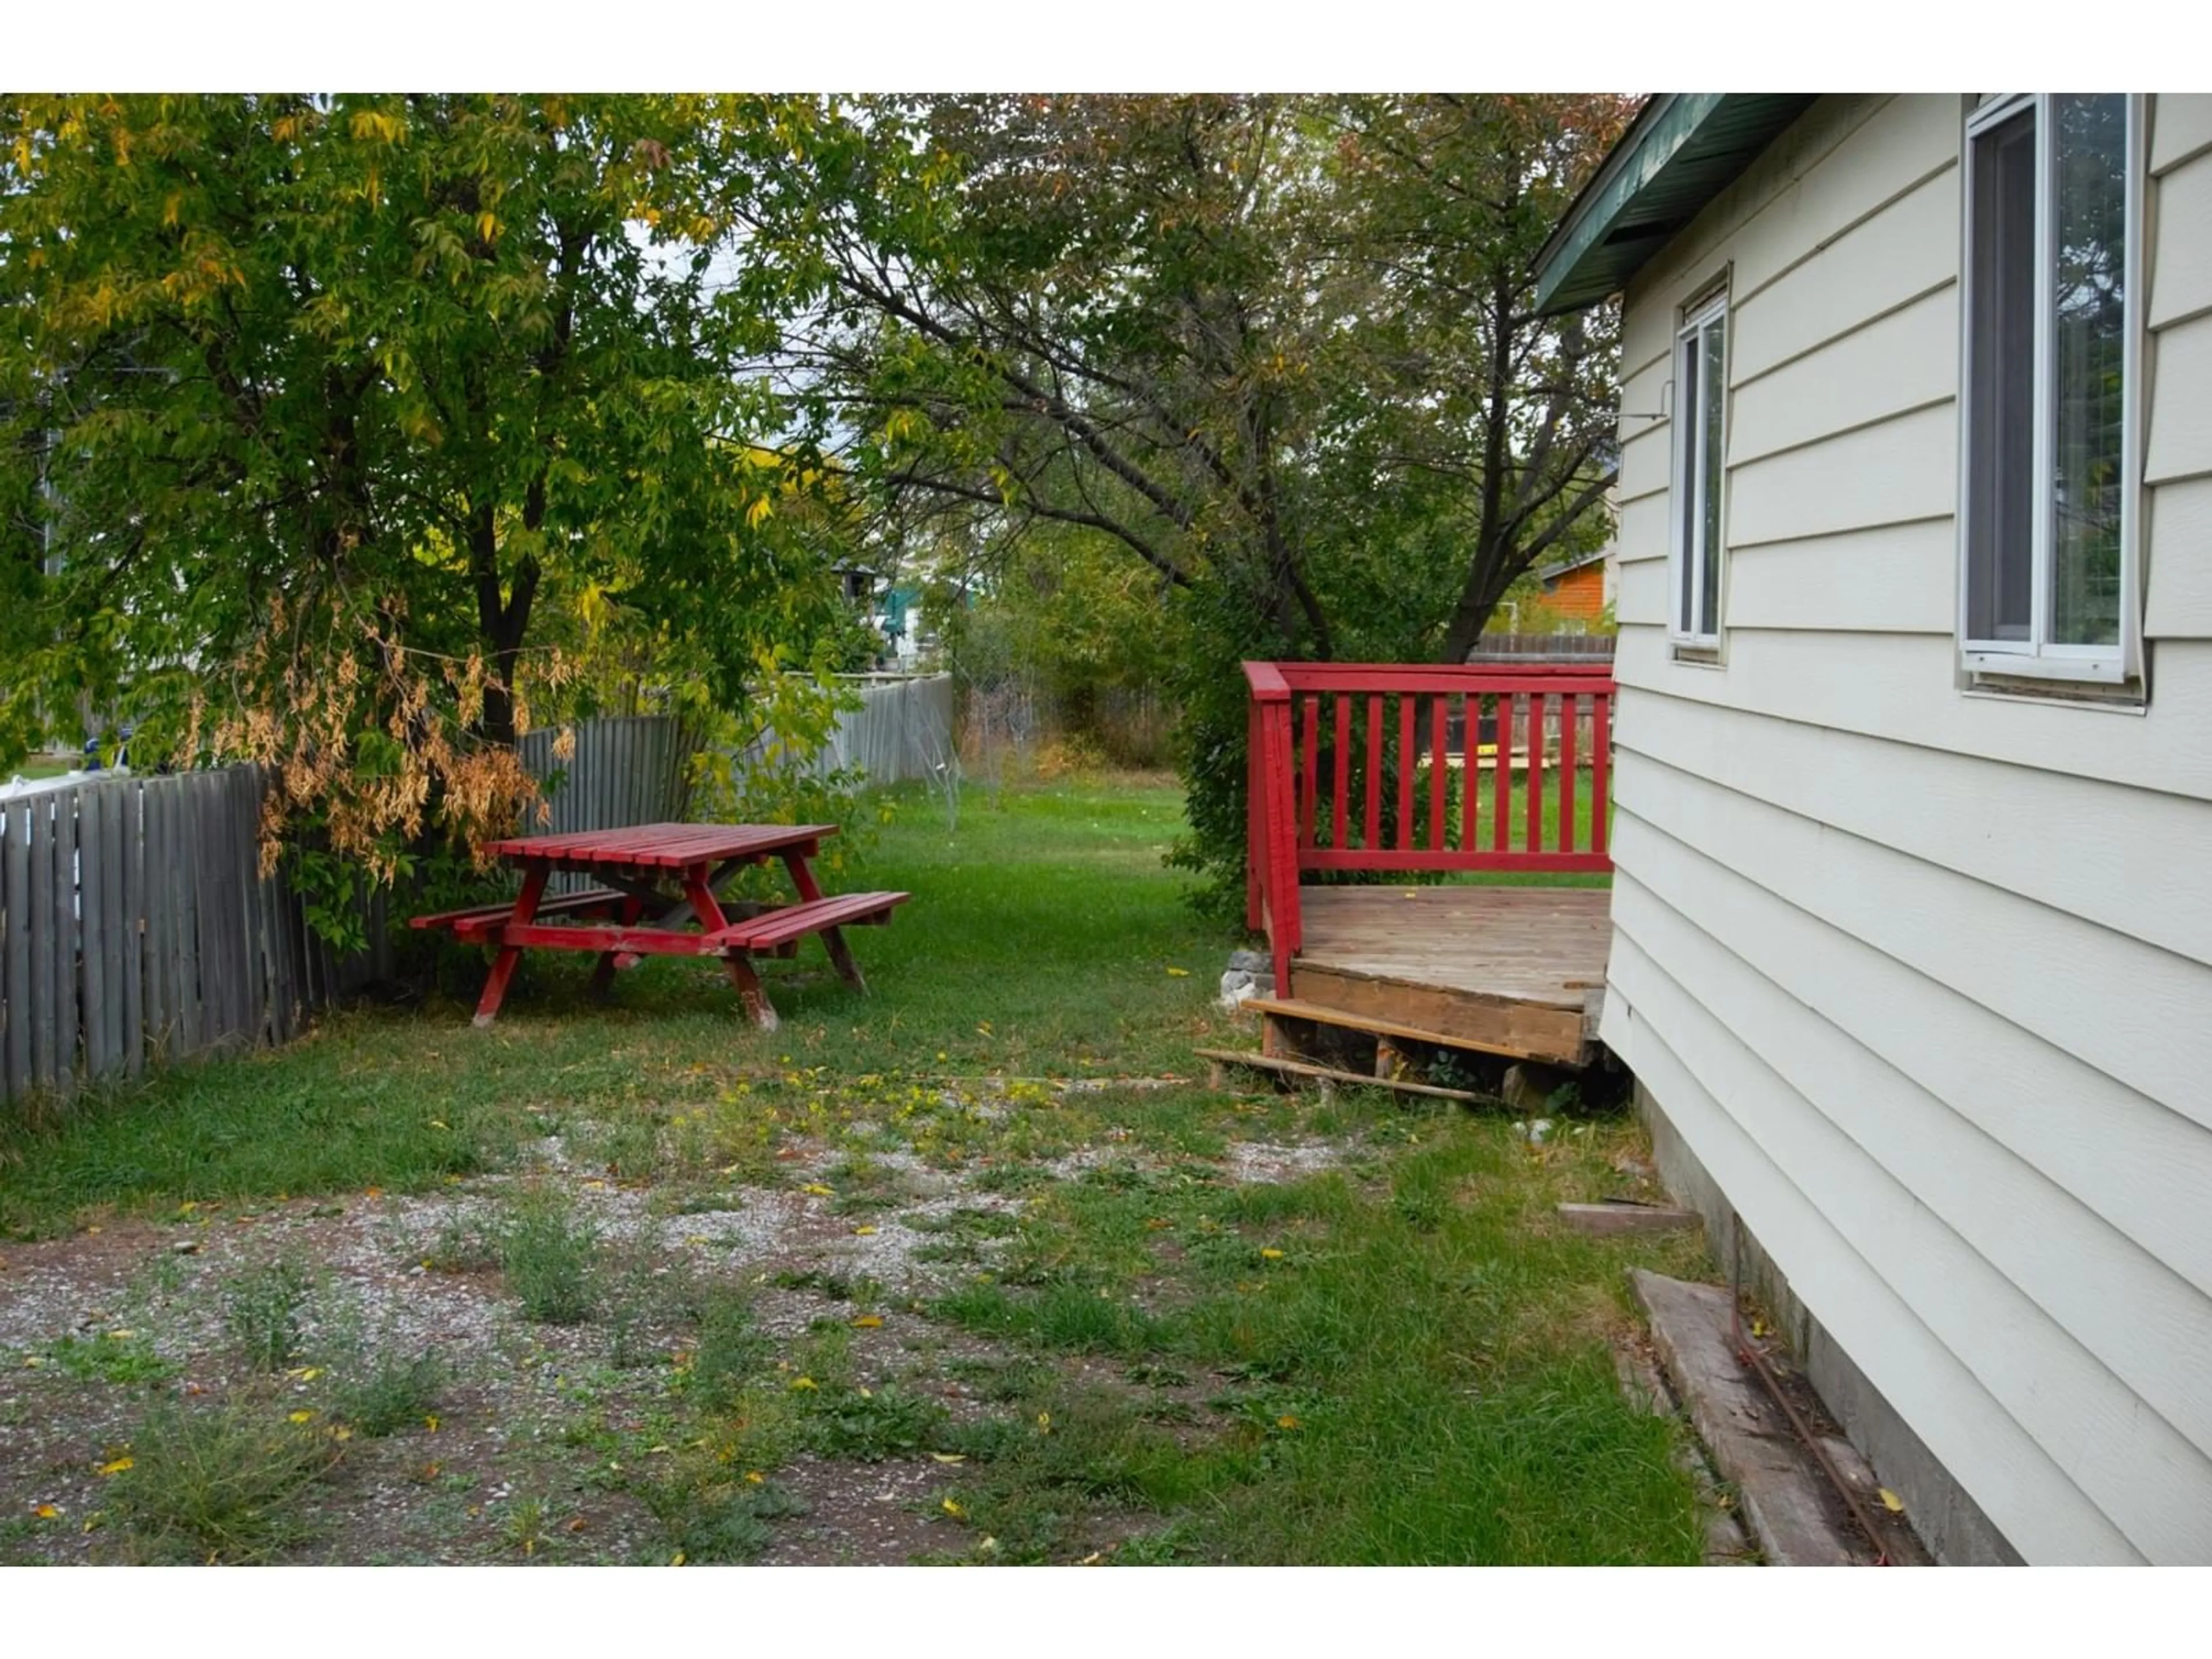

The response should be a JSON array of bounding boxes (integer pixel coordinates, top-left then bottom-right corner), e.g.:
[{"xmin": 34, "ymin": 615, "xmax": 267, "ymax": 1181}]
[{"xmin": 726, "ymin": 97, "xmax": 1628, "ymax": 911}]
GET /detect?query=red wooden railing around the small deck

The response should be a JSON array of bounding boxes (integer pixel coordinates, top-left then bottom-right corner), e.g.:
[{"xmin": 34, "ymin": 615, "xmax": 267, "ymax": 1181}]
[{"xmin": 1243, "ymin": 661, "xmax": 1612, "ymax": 995}]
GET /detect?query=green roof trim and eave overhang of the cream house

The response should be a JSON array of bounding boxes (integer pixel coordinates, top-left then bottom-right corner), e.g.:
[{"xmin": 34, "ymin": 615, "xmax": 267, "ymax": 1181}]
[{"xmin": 1535, "ymin": 93, "xmax": 1812, "ymax": 314}]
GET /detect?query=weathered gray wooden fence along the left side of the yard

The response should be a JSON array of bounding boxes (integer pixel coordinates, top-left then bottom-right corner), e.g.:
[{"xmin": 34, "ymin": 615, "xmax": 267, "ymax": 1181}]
[{"xmin": 0, "ymin": 703, "xmax": 951, "ymax": 1119}]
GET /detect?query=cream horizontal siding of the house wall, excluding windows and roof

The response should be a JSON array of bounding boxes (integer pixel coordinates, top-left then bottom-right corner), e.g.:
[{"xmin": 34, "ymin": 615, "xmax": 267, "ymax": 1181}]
[{"xmin": 1601, "ymin": 95, "xmax": 2212, "ymax": 1562}]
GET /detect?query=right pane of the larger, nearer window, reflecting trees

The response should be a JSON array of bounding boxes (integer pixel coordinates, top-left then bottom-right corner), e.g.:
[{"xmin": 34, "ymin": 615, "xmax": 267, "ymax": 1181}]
[{"xmin": 2051, "ymin": 93, "xmax": 2128, "ymax": 646}]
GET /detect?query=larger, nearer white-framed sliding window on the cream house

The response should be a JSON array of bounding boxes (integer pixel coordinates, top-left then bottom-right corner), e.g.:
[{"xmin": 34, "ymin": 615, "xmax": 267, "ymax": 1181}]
[{"xmin": 1957, "ymin": 93, "xmax": 2143, "ymax": 685}]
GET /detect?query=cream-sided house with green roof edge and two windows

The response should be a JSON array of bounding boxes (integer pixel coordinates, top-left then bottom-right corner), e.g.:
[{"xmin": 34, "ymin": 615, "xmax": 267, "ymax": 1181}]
[{"xmin": 1540, "ymin": 93, "xmax": 2212, "ymax": 1564}]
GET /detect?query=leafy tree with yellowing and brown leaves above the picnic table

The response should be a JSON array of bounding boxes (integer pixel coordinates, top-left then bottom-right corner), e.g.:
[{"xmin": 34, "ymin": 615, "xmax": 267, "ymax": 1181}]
[{"xmin": 0, "ymin": 95, "xmax": 836, "ymax": 872}]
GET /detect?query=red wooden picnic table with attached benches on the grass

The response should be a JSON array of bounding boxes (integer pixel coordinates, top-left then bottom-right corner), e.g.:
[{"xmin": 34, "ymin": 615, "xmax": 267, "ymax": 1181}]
[{"xmin": 414, "ymin": 823, "xmax": 911, "ymax": 1031}]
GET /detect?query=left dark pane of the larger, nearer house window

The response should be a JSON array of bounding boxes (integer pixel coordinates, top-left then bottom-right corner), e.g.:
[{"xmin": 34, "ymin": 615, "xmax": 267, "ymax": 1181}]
[{"xmin": 1967, "ymin": 111, "xmax": 2035, "ymax": 642}]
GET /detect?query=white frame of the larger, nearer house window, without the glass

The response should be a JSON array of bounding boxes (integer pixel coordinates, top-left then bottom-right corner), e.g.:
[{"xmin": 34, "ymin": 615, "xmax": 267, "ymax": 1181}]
[{"xmin": 1957, "ymin": 93, "xmax": 2148, "ymax": 690}]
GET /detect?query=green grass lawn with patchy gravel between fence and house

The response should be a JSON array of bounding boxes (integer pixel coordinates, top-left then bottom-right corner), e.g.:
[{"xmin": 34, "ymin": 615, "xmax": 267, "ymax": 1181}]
[{"xmin": 0, "ymin": 779, "xmax": 1701, "ymax": 1564}]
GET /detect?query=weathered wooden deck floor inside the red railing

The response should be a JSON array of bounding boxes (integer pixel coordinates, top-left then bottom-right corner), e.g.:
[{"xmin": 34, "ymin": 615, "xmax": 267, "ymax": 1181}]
[{"xmin": 1290, "ymin": 887, "xmax": 1612, "ymax": 1066}]
